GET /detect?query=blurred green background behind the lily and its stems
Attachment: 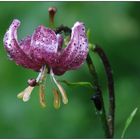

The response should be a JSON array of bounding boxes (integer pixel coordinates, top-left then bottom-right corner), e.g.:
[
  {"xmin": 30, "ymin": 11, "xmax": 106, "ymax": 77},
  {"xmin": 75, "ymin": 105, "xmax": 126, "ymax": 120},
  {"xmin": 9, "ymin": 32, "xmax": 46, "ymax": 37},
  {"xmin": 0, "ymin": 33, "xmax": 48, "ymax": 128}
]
[{"xmin": 0, "ymin": 2, "xmax": 140, "ymax": 138}]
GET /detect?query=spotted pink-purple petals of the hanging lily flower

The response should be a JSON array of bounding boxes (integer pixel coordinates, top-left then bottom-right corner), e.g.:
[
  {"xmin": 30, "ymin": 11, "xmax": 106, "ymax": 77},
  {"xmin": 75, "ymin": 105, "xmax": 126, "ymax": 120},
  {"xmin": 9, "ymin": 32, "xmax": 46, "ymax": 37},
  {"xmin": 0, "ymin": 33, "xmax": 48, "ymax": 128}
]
[{"xmin": 4, "ymin": 19, "xmax": 88, "ymax": 75}]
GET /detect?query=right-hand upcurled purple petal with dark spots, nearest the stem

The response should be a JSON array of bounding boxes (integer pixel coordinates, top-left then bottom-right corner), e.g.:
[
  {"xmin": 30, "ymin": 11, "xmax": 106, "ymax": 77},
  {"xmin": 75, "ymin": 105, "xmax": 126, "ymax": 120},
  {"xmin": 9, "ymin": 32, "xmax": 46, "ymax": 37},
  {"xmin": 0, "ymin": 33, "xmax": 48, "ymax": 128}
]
[{"xmin": 60, "ymin": 22, "xmax": 88, "ymax": 71}]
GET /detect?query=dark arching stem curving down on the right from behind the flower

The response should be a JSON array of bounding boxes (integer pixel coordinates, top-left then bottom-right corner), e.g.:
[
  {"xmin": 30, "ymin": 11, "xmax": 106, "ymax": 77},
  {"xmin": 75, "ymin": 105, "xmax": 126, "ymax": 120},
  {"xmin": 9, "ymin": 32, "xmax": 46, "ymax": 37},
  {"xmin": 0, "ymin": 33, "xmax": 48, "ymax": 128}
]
[{"xmin": 92, "ymin": 45, "xmax": 115, "ymax": 137}]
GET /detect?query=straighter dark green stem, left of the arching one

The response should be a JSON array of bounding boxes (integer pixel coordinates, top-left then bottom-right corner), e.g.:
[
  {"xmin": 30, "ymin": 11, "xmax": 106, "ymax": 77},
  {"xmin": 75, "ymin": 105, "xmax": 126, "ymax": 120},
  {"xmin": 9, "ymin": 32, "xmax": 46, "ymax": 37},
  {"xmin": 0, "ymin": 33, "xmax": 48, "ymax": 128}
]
[{"xmin": 86, "ymin": 54, "xmax": 111, "ymax": 138}]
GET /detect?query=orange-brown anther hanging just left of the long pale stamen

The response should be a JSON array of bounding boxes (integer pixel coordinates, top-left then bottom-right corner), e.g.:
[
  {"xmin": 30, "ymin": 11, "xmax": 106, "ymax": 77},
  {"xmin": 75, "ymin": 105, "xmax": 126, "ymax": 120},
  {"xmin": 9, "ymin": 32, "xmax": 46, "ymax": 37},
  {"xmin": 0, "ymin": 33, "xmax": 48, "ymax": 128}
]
[{"xmin": 53, "ymin": 89, "xmax": 60, "ymax": 109}]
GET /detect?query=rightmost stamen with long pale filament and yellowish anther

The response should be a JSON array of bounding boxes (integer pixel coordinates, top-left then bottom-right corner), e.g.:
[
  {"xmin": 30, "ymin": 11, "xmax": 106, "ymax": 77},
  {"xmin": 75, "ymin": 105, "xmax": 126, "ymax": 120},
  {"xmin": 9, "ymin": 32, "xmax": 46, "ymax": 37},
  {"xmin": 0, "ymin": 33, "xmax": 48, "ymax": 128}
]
[{"xmin": 50, "ymin": 69, "xmax": 68, "ymax": 104}]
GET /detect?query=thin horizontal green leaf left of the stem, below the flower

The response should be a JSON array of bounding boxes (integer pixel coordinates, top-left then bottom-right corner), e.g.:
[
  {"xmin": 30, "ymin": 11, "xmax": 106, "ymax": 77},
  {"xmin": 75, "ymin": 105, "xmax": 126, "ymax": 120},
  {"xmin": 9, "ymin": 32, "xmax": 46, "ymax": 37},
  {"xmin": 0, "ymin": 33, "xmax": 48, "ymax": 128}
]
[{"xmin": 59, "ymin": 80, "xmax": 94, "ymax": 88}]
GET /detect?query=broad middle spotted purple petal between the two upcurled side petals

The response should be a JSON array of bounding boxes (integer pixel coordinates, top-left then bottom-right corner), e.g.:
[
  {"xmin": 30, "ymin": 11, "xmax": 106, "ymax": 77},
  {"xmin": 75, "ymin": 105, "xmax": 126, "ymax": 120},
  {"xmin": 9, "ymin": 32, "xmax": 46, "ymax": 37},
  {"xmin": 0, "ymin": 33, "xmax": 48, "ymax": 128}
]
[{"xmin": 31, "ymin": 25, "xmax": 58, "ymax": 66}]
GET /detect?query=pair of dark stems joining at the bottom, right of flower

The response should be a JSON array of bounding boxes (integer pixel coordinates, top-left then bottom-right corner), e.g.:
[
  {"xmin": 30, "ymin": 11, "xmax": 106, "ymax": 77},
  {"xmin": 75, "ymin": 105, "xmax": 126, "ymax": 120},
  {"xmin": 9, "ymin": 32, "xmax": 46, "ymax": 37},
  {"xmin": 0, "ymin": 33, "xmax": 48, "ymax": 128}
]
[{"xmin": 87, "ymin": 45, "xmax": 115, "ymax": 138}]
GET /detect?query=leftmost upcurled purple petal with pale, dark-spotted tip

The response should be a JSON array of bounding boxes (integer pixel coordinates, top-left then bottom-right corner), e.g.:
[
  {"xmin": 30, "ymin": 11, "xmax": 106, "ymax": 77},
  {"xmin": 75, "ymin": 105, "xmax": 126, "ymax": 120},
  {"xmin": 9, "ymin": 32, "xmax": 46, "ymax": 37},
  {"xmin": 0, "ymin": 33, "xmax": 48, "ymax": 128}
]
[{"xmin": 3, "ymin": 19, "xmax": 39, "ymax": 71}]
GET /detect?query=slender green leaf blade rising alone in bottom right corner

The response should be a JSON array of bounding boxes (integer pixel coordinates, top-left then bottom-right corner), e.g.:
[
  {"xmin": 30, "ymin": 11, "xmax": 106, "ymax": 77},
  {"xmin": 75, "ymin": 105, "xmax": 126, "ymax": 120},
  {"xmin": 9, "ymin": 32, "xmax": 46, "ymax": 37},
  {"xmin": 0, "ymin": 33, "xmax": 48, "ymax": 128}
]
[{"xmin": 121, "ymin": 108, "xmax": 138, "ymax": 138}]
